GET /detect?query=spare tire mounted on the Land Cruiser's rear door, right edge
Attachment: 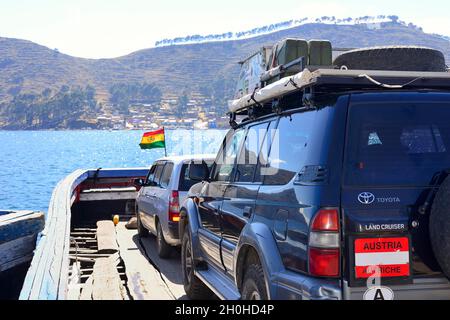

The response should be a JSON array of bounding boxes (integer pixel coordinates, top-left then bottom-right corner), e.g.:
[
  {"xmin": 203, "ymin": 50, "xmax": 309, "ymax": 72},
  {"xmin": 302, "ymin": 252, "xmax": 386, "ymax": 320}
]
[{"xmin": 430, "ymin": 176, "xmax": 450, "ymax": 279}]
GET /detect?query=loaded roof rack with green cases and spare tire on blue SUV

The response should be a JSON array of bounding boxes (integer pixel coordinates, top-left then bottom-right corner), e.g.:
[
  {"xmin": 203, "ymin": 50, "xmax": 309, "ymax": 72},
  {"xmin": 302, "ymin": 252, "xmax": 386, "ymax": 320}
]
[{"xmin": 229, "ymin": 39, "xmax": 450, "ymax": 123}]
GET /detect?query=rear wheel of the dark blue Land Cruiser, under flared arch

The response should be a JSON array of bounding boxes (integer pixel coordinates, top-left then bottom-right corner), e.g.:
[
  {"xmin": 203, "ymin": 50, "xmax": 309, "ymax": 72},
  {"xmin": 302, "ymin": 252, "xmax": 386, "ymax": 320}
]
[{"xmin": 242, "ymin": 264, "xmax": 268, "ymax": 300}]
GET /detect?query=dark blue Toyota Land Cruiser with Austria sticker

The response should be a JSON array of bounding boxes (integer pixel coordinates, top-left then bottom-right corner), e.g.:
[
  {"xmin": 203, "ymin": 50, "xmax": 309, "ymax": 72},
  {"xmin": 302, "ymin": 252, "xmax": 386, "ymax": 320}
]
[{"xmin": 179, "ymin": 45, "xmax": 450, "ymax": 299}]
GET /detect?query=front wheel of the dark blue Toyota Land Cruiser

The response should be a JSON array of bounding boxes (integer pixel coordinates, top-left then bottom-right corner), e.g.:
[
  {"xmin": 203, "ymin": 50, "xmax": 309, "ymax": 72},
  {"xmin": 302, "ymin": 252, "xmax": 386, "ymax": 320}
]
[{"xmin": 181, "ymin": 226, "xmax": 213, "ymax": 300}]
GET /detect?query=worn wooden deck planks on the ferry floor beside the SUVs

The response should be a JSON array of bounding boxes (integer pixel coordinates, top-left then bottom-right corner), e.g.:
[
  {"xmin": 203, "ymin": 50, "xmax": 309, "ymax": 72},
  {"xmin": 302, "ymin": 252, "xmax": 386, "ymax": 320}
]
[{"xmin": 67, "ymin": 220, "xmax": 185, "ymax": 300}]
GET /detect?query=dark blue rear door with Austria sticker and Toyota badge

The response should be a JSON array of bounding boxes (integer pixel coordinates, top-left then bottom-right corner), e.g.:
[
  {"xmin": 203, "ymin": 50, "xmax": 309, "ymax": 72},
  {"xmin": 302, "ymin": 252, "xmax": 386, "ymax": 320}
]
[{"xmin": 341, "ymin": 93, "xmax": 450, "ymax": 299}]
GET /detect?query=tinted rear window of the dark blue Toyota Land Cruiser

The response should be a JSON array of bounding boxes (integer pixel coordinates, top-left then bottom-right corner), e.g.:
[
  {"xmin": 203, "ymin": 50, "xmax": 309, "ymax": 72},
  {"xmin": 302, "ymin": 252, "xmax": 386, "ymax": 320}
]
[{"xmin": 345, "ymin": 102, "xmax": 450, "ymax": 186}]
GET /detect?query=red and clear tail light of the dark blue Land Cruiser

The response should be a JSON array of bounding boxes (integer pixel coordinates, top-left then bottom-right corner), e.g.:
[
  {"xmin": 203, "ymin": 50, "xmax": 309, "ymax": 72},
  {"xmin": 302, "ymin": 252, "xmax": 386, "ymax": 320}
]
[{"xmin": 308, "ymin": 209, "xmax": 340, "ymax": 277}]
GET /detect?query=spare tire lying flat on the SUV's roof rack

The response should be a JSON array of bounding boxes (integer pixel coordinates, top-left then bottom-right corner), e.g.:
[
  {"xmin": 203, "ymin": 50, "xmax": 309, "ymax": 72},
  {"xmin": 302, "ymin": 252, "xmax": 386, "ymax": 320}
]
[{"xmin": 333, "ymin": 46, "xmax": 447, "ymax": 72}]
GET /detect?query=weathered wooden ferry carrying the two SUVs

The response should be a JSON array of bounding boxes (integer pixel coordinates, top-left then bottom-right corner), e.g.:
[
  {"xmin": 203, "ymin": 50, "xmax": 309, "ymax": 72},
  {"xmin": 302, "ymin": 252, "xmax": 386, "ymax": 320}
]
[{"xmin": 20, "ymin": 168, "xmax": 184, "ymax": 300}]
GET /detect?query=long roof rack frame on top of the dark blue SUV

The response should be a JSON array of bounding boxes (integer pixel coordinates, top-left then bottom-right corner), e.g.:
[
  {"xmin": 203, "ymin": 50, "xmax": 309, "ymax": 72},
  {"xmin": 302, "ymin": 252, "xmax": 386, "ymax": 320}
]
[{"xmin": 229, "ymin": 68, "xmax": 450, "ymax": 114}]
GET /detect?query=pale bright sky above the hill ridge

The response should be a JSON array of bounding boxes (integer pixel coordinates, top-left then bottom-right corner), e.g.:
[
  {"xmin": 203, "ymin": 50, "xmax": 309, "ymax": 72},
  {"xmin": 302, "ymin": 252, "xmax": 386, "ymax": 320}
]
[{"xmin": 0, "ymin": 0, "xmax": 450, "ymax": 58}]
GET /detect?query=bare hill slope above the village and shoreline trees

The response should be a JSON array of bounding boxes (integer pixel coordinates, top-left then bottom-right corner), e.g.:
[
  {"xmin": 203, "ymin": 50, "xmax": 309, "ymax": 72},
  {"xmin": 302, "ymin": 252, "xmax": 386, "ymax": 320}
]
[{"xmin": 0, "ymin": 19, "xmax": 450, "ymax": 129}]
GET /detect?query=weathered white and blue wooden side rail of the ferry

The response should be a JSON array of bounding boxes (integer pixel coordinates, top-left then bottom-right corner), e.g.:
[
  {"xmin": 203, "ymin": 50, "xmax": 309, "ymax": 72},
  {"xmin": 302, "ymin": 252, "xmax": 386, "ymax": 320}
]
[{"xmin": 19, "ymin": 168, "xmax": 148, "ymax": 300}]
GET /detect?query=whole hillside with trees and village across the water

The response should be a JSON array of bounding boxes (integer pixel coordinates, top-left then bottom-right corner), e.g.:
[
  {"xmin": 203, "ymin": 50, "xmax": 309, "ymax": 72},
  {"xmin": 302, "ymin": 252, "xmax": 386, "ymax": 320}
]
[{"xmin": 0, "ymin": 16, "xmax": 450, "ymax": 130}]
